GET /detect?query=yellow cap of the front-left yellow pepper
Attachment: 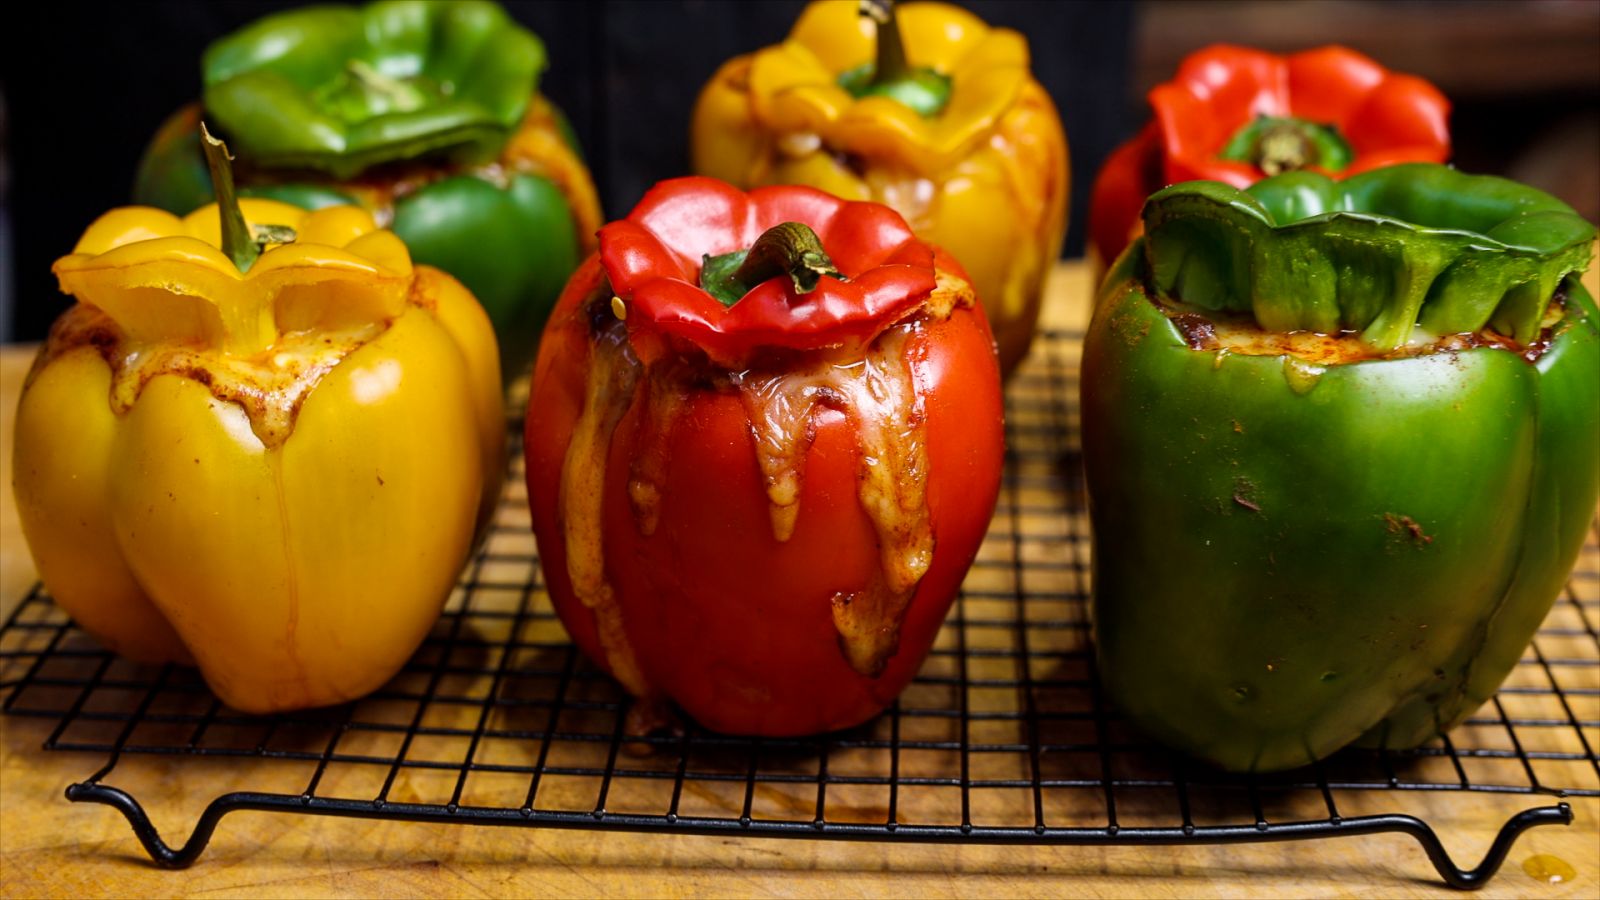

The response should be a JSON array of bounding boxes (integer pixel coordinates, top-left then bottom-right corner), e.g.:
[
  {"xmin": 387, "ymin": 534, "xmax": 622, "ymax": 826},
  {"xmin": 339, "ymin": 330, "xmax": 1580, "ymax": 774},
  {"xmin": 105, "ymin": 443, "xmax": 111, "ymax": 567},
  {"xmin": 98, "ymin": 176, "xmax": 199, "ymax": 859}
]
[{"xmin": 53, "ymin": 199, "xmax": 411, "ymax": 356}]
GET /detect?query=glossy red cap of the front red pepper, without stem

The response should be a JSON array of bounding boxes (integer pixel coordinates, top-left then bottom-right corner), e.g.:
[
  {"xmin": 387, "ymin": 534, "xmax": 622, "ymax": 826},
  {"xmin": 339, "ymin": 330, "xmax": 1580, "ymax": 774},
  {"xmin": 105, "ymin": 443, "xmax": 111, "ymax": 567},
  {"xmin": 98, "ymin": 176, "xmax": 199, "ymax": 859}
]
[{"xmin": 600, "ymin": 176, "xmax": 936, "ymax": 360}]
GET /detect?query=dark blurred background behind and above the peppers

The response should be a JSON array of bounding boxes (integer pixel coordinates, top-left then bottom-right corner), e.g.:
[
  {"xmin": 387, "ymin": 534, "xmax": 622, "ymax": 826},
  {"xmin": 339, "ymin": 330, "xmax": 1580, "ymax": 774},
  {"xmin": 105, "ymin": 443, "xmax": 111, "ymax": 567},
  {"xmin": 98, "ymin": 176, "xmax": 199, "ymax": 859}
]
[{"xmin": 0, "ymin": 0, "xmax": 1600, "ymax": 340}]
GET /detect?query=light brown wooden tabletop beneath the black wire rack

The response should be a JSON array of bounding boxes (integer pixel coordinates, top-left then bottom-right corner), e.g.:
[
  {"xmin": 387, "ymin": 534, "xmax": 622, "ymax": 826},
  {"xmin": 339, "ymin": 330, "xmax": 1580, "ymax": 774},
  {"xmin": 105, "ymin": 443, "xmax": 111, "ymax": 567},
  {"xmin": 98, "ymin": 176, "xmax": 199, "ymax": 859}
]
[{"xmin": 0, "ymin": 263, "xmax": 1600, "ymax": 897}]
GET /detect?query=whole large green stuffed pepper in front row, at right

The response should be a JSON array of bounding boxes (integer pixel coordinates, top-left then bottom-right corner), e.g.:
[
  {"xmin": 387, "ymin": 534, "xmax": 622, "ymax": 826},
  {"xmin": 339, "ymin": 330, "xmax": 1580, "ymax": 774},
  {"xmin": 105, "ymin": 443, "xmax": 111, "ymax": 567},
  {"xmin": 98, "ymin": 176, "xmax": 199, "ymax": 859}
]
[{"xmin": 1082, "ymin": 163, "xmax": 1600, "ymax": 770}]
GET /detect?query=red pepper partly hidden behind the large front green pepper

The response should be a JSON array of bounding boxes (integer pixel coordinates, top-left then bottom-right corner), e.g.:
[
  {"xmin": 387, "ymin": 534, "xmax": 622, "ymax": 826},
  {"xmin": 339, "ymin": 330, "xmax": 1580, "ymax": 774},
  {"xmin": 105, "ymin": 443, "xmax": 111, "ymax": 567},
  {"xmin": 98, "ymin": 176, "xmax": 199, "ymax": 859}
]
[{"xmin": 1090, "ymin": 45, "xmax": 1450, "ymax": 273}]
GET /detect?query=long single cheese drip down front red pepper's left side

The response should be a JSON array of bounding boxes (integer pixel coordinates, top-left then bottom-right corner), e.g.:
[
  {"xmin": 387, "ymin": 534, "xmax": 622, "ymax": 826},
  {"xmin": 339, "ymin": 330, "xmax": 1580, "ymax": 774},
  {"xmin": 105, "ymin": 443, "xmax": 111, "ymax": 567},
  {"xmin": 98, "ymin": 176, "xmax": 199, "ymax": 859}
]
[{"xmin": 560, "ymin": 319, "xmax": 650, "ymax": 697}]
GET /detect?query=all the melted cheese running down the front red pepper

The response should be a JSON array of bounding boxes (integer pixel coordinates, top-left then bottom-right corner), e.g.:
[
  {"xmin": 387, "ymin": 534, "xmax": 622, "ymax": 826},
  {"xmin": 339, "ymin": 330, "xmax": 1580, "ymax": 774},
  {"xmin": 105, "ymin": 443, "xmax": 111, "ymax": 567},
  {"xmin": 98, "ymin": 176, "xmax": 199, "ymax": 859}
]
[{"xmin": 560, "ymin": 272, "xmax": 976, "ymax": 688}]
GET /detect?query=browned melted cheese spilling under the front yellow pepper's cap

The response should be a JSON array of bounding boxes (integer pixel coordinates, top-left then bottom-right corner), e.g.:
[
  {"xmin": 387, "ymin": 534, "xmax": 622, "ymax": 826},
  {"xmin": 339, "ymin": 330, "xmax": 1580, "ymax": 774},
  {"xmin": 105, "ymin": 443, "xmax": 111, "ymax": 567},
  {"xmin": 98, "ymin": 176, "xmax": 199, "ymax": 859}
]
[{"xmin": 35, "ymin": 303, "xmax": 380, "ymax": 447}]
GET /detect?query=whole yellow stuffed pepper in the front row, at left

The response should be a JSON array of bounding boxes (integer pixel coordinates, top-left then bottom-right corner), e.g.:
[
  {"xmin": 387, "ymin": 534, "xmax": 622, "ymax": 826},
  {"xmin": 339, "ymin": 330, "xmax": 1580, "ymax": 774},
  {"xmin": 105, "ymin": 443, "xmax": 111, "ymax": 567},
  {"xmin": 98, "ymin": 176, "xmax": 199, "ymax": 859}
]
[{"xmin": 14, "ymin": 132, "xmax": 504, "ymax": 713}]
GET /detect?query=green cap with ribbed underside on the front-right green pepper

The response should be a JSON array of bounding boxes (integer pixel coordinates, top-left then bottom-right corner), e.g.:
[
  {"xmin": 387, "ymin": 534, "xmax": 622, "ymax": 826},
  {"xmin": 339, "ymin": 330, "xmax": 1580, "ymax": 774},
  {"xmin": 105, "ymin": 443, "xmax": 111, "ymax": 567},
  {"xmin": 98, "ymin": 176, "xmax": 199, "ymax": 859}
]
[{"xmin": 1144, "ymin": 163, "xmax": 1595, "ymax": 351}]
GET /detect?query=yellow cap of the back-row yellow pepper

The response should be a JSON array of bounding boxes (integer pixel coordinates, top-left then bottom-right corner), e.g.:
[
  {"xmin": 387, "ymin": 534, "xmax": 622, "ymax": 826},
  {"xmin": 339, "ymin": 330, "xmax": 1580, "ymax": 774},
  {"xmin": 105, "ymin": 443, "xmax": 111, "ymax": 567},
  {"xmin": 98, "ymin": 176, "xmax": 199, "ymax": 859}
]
[{"xmin": 749, "ymin": 0, "xmax": 1029, "ymax": 175}]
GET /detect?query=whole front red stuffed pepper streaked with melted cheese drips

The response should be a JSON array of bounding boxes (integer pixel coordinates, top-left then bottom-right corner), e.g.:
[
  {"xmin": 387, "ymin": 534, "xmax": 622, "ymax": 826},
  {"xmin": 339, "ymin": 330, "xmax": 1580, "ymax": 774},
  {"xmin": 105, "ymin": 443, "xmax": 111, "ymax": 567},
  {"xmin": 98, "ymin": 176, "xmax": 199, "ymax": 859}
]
[{"xmin": 525, "ymin": 178, "xmax": 1003, "ymax": 735}]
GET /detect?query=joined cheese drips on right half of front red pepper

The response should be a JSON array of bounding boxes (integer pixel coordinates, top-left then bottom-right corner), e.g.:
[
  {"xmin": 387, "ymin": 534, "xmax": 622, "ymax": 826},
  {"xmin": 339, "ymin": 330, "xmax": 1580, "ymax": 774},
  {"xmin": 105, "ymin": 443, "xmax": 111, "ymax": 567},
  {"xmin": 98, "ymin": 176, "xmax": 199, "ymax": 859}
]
[{"xmin": 734, "ymin": 322, "xmax": 933, "ymax": 677}]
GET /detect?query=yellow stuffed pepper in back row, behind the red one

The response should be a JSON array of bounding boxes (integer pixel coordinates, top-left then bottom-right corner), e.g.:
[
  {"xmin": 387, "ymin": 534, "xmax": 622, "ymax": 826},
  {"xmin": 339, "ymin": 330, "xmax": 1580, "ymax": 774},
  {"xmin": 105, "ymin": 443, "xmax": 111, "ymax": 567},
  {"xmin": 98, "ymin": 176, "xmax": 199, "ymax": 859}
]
[{"xmin": 690, "ymin": 0, "xmax": 1069, "ymax": 373}]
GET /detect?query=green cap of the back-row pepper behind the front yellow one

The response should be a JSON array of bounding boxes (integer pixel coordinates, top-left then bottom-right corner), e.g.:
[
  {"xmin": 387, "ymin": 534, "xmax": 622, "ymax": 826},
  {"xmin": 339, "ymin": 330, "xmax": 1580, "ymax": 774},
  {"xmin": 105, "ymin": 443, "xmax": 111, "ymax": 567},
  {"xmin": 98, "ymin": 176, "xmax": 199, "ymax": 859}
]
[{"xmin": 202, "ymin": 0, "xmax": 546, "ymax": 179}]
